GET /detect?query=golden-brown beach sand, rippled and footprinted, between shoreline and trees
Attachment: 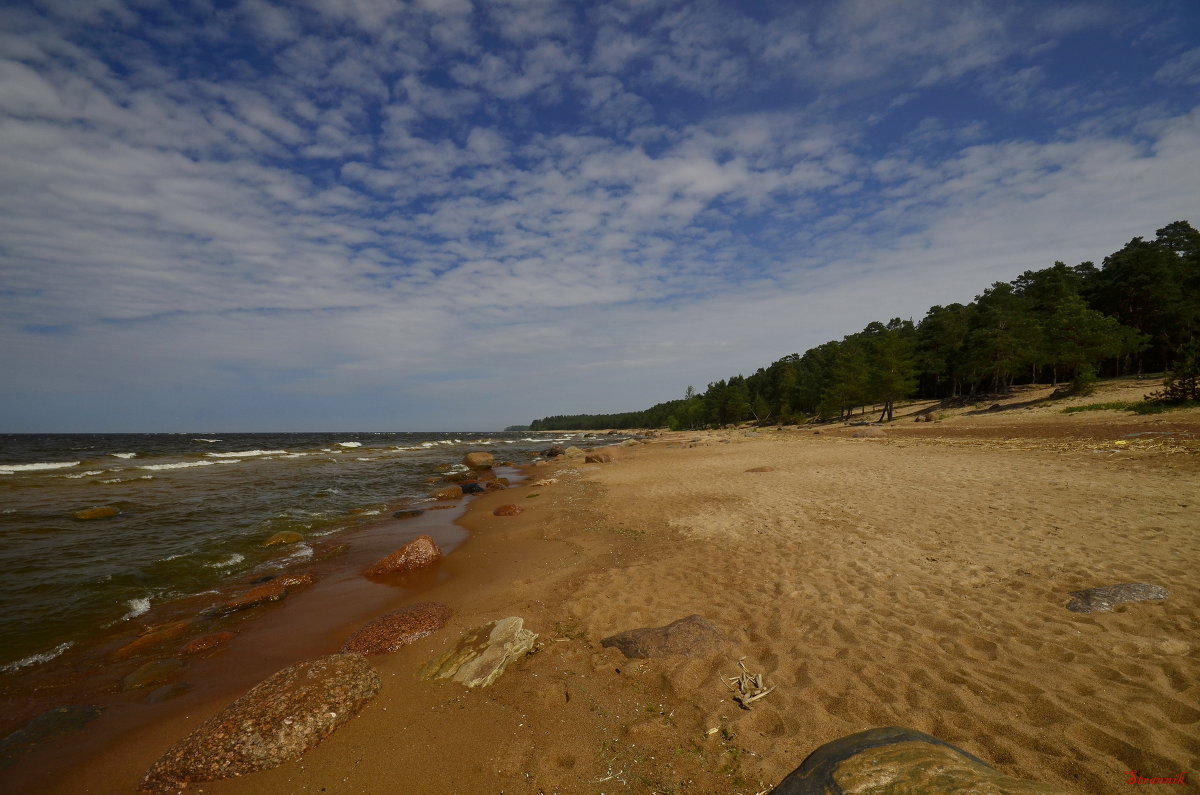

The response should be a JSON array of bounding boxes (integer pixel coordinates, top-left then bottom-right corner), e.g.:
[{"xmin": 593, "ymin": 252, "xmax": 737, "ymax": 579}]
[{"xmin": 28, "ymin": 382, "xmax": 1200, "ymax": 795}]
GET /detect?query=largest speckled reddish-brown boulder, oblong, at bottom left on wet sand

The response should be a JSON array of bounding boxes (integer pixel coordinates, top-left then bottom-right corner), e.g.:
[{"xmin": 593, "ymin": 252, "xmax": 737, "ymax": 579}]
[{"xmin": 140, "ymin": 654, "xmax": 380, "ymax": 793}]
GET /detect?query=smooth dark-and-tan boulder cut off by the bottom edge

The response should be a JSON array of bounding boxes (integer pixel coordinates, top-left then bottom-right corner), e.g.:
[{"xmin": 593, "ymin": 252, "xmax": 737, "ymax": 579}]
[{"xmin": 770, "ymin": 727, "xmax": 1062, "ymax": 795}]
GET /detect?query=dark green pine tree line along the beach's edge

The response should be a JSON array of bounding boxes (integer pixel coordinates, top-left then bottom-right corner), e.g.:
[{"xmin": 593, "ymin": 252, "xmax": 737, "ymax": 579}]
[{"xmin": 530, "ymin": 221, "xmax": 1200, "ymax": 430}]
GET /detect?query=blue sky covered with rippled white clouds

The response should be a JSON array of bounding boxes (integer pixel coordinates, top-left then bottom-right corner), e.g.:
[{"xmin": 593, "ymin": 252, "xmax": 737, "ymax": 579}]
[{"xmin": 0, "ymin": 0, "xmax": 1200, "ymax": 432}]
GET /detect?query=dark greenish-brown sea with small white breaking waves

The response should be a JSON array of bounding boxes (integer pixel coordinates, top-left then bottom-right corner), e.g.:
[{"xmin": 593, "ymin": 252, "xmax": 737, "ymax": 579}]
[{"xmin": 0, "ymin": 431, "xmax": 604, "ymax": 676}]
